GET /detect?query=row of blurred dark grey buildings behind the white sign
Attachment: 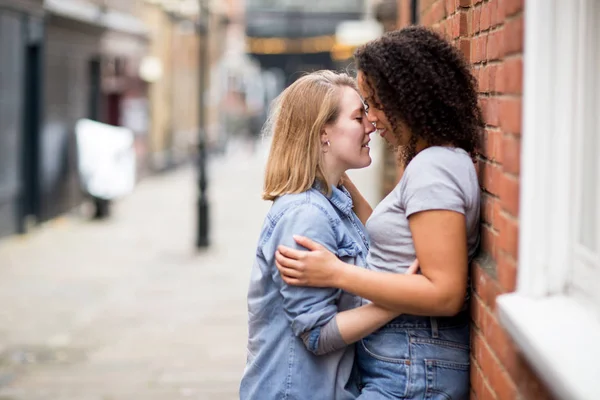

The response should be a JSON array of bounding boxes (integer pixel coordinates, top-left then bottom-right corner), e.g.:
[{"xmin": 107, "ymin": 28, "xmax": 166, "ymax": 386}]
[{"xmin": 0, "ymin": 0, "xmax": 148, "ymax": 235}]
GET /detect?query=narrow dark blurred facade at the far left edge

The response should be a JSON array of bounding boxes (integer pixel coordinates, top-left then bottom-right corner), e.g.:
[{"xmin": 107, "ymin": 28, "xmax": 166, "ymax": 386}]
[{"xmin": 0, "ymin": 0, "xmax": 44, "ymax": 236}]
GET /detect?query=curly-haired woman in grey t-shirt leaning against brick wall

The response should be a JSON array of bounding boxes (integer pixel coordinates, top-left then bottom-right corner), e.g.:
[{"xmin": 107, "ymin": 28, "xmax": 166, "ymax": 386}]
[{"xmin": 276, "ymin": 27, "xmax": 484, "ymax": 399}]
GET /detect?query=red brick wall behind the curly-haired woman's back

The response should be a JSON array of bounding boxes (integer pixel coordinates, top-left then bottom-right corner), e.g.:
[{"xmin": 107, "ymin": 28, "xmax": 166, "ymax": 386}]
[{"xmin": 390, "ymin": 0, "xmax": 550, "ymax": 400}]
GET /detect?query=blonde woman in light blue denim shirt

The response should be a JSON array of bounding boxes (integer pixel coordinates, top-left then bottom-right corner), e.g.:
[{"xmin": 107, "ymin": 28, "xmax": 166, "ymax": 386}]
[{"xmin": 240, "ymin": 71, "xmax": 418, "ymax": 400}]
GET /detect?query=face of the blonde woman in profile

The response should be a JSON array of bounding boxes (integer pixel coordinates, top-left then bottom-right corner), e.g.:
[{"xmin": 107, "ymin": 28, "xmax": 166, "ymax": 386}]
[{"xmin": 324, "ymin": 86, "xmax": 375, "ymax": 171}]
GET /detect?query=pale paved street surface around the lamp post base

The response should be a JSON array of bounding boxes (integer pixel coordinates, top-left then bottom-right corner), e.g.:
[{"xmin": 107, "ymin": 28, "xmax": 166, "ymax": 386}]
[{"xmin": 0, "ymin": 136, "xmax": 379, "ymax": 400}]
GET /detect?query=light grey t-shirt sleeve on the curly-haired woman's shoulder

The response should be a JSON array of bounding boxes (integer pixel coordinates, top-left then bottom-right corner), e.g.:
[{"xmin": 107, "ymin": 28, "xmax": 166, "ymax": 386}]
[{"xmin": 400, "ymin": 153, "xmax": 467, "ymax": 218}]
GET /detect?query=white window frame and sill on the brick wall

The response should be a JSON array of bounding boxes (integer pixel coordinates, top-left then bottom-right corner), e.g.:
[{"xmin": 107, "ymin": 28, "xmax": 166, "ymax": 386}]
[{"xmin": 497, "ymin": 0, "xmax": 600, "ymax": 400}]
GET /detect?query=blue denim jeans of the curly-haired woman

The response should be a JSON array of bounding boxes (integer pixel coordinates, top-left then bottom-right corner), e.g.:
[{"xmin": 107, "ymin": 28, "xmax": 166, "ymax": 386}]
[{"xmin": 356, "ymin": 311, "xmax": 469, "ymax": 400}]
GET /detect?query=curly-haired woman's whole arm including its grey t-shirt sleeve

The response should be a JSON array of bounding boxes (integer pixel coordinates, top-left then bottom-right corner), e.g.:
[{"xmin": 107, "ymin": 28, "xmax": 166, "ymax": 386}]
[{"xmin": 278, "ymin": 153, "xmax": 468, "ymax": 316}]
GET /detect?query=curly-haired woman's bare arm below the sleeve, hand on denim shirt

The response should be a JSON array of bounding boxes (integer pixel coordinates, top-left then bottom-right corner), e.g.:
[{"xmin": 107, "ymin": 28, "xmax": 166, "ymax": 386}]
[{"xmin": 276, "ymin": 210, "xmax": 468, "ymax": 316}]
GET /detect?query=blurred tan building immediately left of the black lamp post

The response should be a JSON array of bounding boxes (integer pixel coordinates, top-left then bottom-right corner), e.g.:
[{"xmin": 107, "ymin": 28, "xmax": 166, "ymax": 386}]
[{"xmin": 142, "ymin": 0, "xmax": 200, "ymax": 170}]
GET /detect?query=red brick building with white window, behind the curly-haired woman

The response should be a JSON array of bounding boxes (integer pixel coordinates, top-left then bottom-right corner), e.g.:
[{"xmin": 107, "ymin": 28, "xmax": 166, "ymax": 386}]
[{"xmin": 384, "ymin": 0, "xmax": 600, "ymax": 400}]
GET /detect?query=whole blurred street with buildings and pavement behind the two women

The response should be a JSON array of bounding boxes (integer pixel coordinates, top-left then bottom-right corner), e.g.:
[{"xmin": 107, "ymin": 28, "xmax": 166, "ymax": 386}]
[{"xmin": 0, "ymin": 0, "xmax": 396, "ymax": 400}]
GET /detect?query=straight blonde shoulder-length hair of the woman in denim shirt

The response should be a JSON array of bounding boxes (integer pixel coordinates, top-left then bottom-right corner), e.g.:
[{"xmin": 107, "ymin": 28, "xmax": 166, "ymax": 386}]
[{"xmin": 262, "ymin": 71, "xmax": 357, "ymax": 200}]
